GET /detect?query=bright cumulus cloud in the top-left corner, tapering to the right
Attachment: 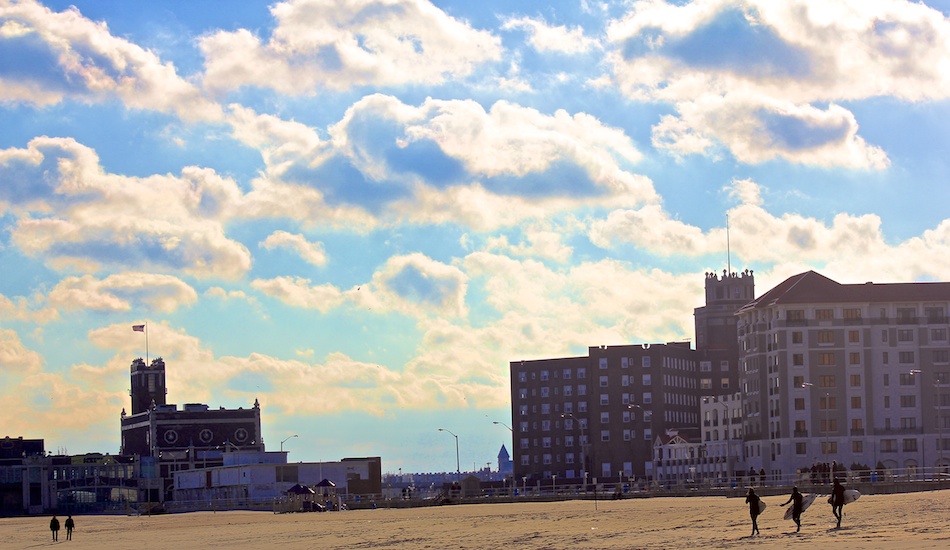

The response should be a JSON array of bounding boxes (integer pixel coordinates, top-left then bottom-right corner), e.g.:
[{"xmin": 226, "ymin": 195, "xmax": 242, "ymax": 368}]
[{"xmin": 0, "ymin": 0, "xmax": 222, "ymax": 120}]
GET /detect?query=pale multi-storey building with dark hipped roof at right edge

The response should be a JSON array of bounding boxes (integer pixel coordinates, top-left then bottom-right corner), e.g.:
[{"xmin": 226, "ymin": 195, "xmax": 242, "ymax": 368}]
[{"xmin": 736, "ymin": 271, "xmax": 950, "ymax": 477}]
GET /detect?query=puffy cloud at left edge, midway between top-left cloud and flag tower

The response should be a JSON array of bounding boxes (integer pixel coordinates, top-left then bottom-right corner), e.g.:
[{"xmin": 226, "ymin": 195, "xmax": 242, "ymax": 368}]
[{"xmin": 0, "ymin": 137, "xmax": 250, "ymax": 278}]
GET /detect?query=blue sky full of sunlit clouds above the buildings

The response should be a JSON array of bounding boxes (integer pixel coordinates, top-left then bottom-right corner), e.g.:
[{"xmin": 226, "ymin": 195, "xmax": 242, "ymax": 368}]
[{"xmin": 0, "ymin": 0, "xmax": 950, "ymax": 472}]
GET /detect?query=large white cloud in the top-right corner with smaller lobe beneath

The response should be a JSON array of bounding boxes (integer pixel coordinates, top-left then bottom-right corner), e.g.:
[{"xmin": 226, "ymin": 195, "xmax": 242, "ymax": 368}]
[{"xmin": 608, "ymin": 0, "xmax": 950, "ymax": 170}]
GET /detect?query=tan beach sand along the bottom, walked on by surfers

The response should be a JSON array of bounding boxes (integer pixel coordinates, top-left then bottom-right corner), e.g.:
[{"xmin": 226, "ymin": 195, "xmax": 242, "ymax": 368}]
[{"xmin": 0, "ymin": 490, "xmax": 950, "ymax": 550}]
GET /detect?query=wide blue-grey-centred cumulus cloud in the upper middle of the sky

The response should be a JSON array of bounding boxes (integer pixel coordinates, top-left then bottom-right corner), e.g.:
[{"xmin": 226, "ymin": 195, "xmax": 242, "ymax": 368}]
[{"xmin": 231, "ymin": 94, "xmax": 656, "ymax": 230}]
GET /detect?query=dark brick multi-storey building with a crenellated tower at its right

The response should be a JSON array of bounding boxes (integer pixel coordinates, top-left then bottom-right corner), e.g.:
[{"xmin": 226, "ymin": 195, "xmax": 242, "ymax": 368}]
[{"xmin": 509, "ymin": 271, "xmax": 755, "ymax": 483}]
